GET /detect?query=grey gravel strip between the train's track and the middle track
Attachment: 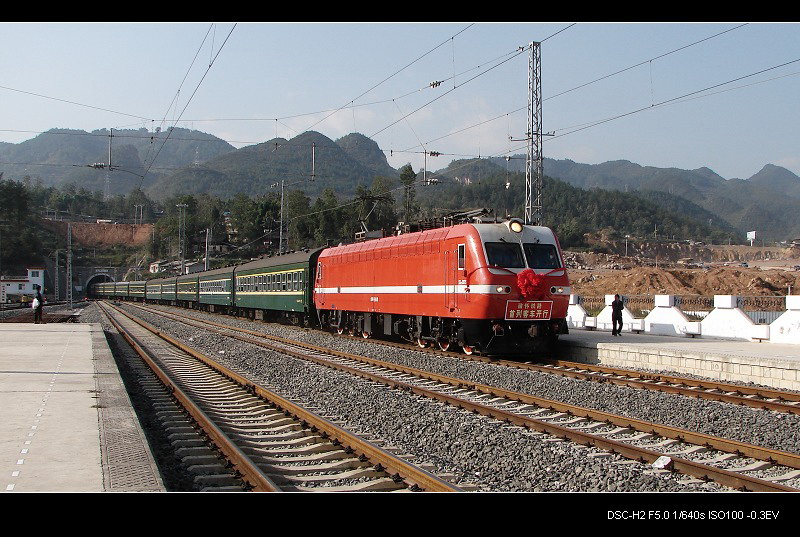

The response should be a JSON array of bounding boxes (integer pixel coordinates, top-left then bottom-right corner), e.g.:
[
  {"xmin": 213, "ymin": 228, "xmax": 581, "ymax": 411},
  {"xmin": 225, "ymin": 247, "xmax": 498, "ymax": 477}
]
[{"xmin": 120, "ymin": 304, "xmax": 800, "ymax": 453}]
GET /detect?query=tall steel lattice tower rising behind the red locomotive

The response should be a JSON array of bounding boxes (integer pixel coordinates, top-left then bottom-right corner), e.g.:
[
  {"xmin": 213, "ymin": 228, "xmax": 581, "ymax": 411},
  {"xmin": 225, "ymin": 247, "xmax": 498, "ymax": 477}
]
[{"xmin": 525, "ymin": 42, "xmax": 543, "ymax": 226}]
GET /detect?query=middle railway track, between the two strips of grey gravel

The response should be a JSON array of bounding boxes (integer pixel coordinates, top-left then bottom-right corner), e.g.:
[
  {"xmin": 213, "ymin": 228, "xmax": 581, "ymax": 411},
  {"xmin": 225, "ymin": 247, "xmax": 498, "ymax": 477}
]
[{"xmin": 120, "ymin": 306, "xmax": 800, "ymax": 491}]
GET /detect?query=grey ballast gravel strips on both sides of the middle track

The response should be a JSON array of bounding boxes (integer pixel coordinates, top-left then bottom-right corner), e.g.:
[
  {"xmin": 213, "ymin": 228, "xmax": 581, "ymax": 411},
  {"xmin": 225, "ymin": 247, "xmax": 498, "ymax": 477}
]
[{"xmin": 86, "ymin": 305, "xmax": 800, "ymax": 492}]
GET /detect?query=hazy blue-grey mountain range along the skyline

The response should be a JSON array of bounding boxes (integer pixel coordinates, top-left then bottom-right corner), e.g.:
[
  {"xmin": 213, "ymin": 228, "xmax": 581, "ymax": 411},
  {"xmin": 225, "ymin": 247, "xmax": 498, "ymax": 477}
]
[{"xmin": 0, "ymin": 128, "xmax": 800, "ymax": 240}]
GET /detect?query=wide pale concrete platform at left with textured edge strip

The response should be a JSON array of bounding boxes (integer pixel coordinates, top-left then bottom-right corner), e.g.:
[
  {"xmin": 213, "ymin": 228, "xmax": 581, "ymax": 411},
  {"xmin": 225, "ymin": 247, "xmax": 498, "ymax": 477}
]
[{"xmin": 0, "ymin": 323, "xmax": 164, "ymax": 492}]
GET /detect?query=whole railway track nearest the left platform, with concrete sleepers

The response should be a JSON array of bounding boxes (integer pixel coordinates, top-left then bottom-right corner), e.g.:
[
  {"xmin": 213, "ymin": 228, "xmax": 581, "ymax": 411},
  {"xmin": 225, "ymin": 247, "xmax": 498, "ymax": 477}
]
[{"xmin": 101, "ymin": 306, "xmax": 460, "ymax": 491}]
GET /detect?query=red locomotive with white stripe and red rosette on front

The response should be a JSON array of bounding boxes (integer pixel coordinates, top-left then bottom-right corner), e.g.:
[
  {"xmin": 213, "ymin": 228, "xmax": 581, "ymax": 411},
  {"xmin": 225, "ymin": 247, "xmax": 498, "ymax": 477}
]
[{"xmin": 314, "ymin": 219, "xmax": 570, "ymax": 354}]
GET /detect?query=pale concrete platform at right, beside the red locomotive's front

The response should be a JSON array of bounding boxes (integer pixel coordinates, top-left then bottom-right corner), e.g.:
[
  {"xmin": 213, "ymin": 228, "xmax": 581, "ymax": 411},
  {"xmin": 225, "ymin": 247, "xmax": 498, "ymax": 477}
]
[{"xmin": 559, "ymin": 329, "xmax": 800, "ymax": 391}]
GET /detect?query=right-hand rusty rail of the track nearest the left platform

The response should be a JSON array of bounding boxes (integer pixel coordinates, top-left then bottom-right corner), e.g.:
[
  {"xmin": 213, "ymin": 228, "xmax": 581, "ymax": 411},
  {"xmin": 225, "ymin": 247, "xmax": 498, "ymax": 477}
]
[{"xmin": 103, "ymin": 300, "xmax": 462, "ymax": 492}]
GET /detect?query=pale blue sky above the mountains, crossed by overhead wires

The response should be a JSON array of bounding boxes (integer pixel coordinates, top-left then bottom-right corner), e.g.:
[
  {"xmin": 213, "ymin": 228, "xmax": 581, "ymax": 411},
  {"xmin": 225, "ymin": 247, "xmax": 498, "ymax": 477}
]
[{"xmin": 0, "ymin": 21, "xmax": 800, "ymax": 179}]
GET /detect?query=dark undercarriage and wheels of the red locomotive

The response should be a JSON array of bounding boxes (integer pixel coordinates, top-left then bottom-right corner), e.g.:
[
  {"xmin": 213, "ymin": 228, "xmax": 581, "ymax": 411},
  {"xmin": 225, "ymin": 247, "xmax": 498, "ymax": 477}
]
[{"xmin": 319, "ymin": 310, "xmax": 568, "ymax": 354}]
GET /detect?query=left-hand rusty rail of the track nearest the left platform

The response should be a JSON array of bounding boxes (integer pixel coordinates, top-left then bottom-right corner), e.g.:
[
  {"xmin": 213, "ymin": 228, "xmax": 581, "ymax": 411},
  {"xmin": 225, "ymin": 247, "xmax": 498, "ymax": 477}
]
[{"xmin": 101, "ymin": 306, "xmax": 281, "ymax": 492}]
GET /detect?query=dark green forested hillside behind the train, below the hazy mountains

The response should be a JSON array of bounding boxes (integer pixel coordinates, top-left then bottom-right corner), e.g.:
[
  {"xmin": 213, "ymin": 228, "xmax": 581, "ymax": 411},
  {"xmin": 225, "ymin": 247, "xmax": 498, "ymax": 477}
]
[{"xmin": 0, "ymin": 168, "xmax": 742, "ymax": 272}]
